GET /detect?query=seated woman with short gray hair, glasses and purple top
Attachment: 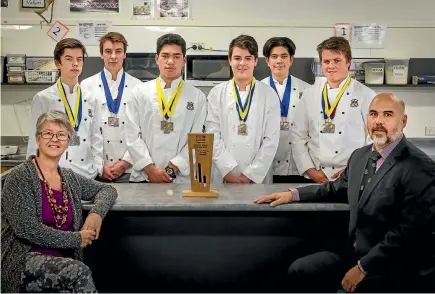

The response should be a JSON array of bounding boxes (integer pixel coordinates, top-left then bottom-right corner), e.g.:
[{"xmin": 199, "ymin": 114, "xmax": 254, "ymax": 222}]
[{"xmin": 1, "ymin": 111, "xmax": 118, "ymax": 292}]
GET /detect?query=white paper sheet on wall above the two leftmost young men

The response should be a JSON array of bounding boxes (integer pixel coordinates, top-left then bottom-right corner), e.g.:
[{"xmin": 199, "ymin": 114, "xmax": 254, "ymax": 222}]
[{"xmin": 77, "ymin": 21, "xmax": 112, "ymax": 46}]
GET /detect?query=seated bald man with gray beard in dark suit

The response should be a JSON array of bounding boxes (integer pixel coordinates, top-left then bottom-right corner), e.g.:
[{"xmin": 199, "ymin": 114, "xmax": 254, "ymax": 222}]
[{"xmin": 255, "ymin": 93, "xmax": 435, "ymax": 292}]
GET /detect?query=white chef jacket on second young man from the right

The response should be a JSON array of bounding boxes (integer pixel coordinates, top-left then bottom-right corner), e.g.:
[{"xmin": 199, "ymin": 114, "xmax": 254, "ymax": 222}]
[{"xmin": 261, "ymin": 76, "xmax": 310, "ymax": 176}]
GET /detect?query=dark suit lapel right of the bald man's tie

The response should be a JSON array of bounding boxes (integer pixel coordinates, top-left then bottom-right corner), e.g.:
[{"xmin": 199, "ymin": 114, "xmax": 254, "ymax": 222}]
[{"xmin": 358, "ymin": 137, "xmax": 406, "ymax": 208}]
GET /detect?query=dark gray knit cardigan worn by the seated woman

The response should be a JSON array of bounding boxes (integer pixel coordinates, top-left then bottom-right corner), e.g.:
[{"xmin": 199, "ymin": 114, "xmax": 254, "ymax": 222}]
[{"xmin": 1, "ymin": 156, "xmax": 118, "ymax": 293}]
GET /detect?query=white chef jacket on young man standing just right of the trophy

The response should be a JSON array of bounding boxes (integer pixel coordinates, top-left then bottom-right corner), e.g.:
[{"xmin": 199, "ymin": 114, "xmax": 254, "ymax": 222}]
[{"xmin": 205, "ymin": 80, "xmax": 281, "ymax": 183}]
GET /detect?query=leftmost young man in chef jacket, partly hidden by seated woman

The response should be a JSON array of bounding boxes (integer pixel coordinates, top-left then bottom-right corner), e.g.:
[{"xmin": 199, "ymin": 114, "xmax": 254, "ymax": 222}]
[{"xmin": 27, "ymin": 38, "xmax": 103, "ymax": 179}]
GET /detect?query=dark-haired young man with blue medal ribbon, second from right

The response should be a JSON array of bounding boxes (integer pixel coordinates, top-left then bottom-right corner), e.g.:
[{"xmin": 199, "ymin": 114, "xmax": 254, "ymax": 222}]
[{"xmin": 262, "ymin": 37, "xmax": 310, "ymax": 183}]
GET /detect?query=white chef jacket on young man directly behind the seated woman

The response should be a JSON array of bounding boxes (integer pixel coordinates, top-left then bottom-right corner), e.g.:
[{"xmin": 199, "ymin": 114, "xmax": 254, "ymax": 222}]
[{"xmin": 27, "ymin": 79, "xmax": 103, "ymax": 179}]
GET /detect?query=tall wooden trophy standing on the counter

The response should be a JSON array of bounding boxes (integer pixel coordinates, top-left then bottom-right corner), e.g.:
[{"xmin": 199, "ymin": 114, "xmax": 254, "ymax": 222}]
[{"xmin": 183, "ymin": 133, "xmax": 218, "ymax": 197}]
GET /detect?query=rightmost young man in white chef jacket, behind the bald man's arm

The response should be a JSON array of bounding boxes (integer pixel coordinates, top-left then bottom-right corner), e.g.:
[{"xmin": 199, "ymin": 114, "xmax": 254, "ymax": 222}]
[{"xmin": 291, "ymin": 37, "xmax": 376, "ymax": 183}]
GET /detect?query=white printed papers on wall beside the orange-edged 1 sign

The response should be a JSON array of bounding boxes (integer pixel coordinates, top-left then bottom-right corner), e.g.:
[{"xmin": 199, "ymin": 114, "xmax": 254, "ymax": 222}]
[{"xmin": 352, "ymin": 23, "xmax": 387, "ymax": 49}]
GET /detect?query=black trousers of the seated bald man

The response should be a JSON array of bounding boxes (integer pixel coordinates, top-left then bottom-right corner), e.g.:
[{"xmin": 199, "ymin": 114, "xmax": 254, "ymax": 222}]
[{"xmin": 288, "ymin": 251, "xmax": 422, "ymax": 293}]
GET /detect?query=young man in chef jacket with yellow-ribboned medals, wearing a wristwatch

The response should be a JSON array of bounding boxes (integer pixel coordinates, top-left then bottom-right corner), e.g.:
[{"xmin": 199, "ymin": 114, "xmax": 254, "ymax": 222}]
[{"xmin": 125, "ymin": 34, "xmax": 207, "ymax": 183}]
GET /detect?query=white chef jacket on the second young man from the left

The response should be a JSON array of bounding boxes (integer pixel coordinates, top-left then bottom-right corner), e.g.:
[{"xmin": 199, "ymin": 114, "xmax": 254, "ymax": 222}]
[{"xmin": 81, "ymin": 68, "xmax": 142, "ymax": 173}]
